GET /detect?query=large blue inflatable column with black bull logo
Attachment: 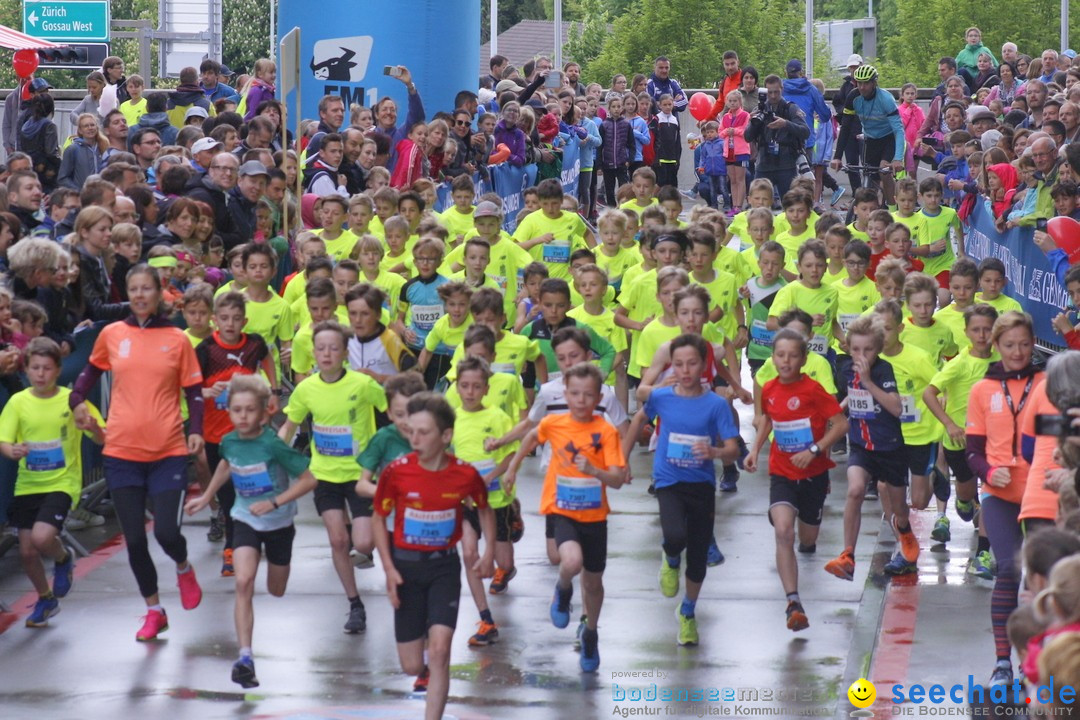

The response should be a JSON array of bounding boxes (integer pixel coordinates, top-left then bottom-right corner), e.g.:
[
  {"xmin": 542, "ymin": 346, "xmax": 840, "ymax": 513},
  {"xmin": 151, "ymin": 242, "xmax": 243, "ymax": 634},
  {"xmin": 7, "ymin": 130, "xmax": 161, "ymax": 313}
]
[{"xmin": 278, "ymin": 0, "xmax": 481, "ymax": 131}]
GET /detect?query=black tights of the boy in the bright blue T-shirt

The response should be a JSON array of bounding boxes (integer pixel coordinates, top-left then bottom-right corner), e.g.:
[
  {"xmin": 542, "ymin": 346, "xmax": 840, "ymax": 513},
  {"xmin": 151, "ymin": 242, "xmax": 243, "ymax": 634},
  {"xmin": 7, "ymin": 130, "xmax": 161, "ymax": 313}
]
[{"xmin": 657, "ymin": 483, "xmax": 716, "ymax": 583}]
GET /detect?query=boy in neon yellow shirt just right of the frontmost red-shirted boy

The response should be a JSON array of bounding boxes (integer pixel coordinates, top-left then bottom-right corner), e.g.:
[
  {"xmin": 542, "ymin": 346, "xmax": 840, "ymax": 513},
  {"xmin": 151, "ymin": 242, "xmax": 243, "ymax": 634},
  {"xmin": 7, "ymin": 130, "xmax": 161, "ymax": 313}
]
[{"xmin": 454, "ymin": 356, "xmax": 517, "ymax": 647}]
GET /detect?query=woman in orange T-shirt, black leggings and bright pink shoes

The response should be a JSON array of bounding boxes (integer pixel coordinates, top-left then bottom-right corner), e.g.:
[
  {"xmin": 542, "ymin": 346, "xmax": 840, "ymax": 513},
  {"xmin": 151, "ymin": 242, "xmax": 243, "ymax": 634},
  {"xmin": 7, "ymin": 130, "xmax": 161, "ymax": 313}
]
[{"xmin": 70, "ymin": 264, "xmax": 203, "ymax": 641}]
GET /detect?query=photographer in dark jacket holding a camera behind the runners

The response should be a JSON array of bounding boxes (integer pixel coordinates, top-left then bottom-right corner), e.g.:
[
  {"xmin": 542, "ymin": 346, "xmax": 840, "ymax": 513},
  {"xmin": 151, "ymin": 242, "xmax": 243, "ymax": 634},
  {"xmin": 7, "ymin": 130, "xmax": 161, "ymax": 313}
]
[{"xmin": 745, "ymin": 74, "xmax": 810, "ymax": 196}]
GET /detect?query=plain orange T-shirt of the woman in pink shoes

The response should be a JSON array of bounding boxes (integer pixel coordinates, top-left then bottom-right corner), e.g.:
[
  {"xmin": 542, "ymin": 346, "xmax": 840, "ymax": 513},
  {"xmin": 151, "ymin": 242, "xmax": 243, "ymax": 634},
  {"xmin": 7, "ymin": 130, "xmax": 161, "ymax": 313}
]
[{"xmin": 90, "ymin": 321, "xmax": 202, "ymax": 462}]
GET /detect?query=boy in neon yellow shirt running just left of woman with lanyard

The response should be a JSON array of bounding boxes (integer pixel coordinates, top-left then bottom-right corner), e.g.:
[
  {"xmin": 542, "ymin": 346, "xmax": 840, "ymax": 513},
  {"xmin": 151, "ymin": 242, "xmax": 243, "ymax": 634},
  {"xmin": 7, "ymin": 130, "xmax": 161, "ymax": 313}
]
[{"xmin": 922, "ymin": 304, "xmax": 1000, "ymax": 580}]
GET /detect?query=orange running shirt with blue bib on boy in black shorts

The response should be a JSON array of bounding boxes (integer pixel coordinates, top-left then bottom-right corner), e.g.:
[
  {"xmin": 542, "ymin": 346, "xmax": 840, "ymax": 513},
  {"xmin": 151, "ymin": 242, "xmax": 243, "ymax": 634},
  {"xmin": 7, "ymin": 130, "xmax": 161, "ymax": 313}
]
[{"xmin": 537, "ymin": 413, "xmax": 625, "ymax": 522}]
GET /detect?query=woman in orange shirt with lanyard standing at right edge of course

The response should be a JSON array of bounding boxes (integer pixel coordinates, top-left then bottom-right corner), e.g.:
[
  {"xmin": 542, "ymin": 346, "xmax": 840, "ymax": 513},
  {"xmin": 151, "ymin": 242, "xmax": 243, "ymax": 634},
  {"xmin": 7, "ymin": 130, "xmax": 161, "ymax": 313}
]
[{"xmin": 966, "ymin": 311, "xmax": 1043, "ymax": 685}]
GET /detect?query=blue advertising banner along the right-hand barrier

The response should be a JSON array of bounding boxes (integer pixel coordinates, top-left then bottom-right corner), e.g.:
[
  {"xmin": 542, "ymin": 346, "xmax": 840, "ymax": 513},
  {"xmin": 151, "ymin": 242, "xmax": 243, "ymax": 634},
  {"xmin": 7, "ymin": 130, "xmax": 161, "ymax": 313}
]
[{"xmin": 964, "ymin": 198, "xmax": 1068, "ymax": 348}]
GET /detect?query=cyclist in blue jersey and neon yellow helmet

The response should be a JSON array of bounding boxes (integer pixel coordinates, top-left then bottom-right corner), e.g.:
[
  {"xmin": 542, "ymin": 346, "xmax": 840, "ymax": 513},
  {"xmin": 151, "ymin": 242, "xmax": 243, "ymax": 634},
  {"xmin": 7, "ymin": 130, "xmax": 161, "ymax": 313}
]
[{"xmin": 829, "ymin": 65, "xmax": 904, "ymax": 204}]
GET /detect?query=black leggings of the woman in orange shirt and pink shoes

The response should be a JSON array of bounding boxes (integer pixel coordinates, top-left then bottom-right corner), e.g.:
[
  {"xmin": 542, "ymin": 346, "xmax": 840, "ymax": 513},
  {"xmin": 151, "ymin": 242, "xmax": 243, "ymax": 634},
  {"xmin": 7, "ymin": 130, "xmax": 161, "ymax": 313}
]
[{"xmin": 111, "ymin": 487, "xmax": 188, "ymax": 598}]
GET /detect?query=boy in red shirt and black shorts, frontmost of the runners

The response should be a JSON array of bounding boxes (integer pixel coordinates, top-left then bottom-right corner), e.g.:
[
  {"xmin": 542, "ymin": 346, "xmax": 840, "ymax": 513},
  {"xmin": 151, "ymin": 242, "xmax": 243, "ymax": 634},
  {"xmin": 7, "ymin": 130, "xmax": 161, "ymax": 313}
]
[{"xmin": 373, "ymin": 393, "xmax": 496, "ymax": 720}]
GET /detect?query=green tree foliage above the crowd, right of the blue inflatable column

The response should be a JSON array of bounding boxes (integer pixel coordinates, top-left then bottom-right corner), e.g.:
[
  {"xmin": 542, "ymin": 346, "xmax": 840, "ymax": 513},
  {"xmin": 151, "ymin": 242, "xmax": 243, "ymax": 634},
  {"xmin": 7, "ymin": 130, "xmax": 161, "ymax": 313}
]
[{"xmin": 582, "ymin": 0, "xmax": 804, "ymax": 87}]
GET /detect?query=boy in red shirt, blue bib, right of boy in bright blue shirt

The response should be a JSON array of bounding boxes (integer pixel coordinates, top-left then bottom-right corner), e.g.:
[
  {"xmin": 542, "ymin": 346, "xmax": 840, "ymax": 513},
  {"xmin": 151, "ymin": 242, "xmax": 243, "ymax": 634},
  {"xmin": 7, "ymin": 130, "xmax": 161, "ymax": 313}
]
[{"xmin": 743, "ymin": 330, "xmax": 848, "ymax": 633}]
